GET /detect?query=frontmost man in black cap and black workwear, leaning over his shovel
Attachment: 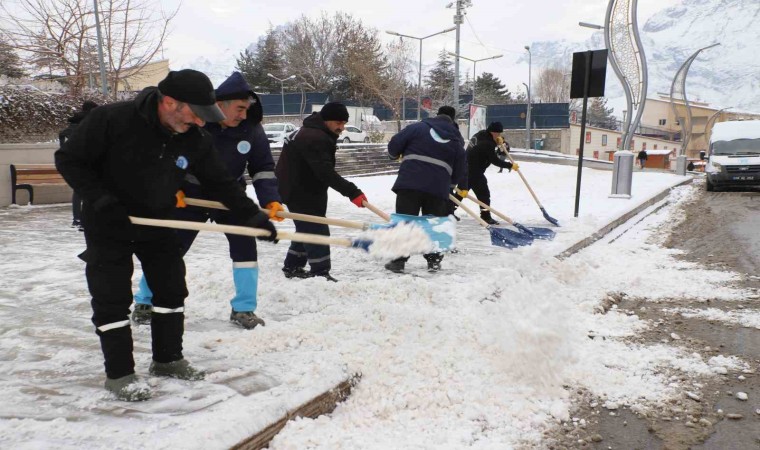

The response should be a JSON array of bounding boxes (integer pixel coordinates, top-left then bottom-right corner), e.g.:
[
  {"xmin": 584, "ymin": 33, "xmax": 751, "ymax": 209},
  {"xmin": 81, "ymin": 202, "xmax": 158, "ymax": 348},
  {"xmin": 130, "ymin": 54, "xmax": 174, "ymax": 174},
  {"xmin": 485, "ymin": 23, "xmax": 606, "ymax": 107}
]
[{"xmin": 55, "ymin": 69, "xmax": 276, "ymax": 401}]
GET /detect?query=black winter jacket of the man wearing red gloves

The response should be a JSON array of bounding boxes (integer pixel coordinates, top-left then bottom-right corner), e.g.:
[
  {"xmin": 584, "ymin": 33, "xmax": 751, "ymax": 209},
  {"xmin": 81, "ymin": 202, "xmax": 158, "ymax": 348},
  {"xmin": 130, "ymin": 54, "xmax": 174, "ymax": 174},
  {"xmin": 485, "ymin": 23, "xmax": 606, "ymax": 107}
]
[{"xmin": 275, "ymin": 113, "xmax": 362, "ymax": 211}]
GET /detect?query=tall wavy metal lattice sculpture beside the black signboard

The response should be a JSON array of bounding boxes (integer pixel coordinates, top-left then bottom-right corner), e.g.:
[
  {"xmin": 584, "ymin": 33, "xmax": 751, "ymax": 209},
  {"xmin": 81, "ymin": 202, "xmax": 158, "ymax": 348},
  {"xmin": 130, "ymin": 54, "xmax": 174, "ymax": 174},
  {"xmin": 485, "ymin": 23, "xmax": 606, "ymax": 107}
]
[{"xmin": 604, "ymin": 0, "xmax": 647, "ymax": 150}]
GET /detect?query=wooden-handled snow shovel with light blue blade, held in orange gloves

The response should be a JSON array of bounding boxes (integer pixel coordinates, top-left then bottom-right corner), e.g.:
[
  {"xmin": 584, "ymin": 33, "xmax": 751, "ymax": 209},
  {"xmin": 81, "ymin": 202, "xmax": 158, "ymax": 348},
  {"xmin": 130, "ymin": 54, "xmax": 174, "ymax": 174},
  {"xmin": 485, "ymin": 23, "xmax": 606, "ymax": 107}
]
[{"xmin": 183, "ymin": 197, "xmax": 456, "ymax": 251}]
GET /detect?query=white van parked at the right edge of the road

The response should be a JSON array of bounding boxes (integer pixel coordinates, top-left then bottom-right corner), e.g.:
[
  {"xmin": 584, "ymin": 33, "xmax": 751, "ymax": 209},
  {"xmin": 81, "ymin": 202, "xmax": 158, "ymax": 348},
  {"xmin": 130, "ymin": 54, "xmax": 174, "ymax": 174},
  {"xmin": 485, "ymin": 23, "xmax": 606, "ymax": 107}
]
[{"xmin": 702, "ymin": 120, "xmax": 760, "ymax": 191}]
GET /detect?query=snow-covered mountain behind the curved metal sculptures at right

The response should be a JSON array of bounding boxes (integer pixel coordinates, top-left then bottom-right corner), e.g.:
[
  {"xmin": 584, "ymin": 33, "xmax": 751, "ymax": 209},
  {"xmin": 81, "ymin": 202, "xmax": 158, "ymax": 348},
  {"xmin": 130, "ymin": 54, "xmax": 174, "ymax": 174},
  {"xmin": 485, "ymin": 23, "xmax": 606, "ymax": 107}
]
[{"xmin": 531, "ymin": 0, "xmax": 760, "ymax": 115}]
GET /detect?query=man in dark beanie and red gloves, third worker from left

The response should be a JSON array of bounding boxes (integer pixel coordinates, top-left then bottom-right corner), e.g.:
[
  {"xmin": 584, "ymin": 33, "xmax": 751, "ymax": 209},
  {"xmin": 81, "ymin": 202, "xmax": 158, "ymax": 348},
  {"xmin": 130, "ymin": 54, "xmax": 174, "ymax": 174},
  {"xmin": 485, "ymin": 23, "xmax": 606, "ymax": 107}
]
[{"xmin": 275, "ymin": 102, "xmax": 367, "ymax": 281}]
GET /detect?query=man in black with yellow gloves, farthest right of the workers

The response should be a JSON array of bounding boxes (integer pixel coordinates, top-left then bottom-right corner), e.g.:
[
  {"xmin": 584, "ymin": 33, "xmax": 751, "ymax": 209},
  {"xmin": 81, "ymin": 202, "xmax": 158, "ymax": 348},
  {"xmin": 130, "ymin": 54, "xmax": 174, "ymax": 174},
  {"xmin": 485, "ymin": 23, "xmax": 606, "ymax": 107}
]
[{"xmin": 467, "ymin": 122, "xmax": 518, "ymax": 225}]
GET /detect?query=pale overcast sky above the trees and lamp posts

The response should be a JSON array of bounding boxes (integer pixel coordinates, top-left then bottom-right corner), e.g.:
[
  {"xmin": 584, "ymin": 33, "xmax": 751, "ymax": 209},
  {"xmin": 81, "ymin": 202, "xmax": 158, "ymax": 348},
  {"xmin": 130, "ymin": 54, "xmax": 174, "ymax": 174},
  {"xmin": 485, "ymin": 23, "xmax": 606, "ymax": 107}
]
[{"xmin": 162, "ymin": 0, "xmax": 680, "ymax": 90}]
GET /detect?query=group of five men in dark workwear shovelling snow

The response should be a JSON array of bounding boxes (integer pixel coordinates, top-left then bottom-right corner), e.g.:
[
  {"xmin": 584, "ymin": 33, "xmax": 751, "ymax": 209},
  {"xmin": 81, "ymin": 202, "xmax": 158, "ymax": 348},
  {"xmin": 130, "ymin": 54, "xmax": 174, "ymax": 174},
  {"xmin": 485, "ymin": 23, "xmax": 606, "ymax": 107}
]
[{"xmin": 55, "ymin": 69, "xmax": 516, "ymax": 401}]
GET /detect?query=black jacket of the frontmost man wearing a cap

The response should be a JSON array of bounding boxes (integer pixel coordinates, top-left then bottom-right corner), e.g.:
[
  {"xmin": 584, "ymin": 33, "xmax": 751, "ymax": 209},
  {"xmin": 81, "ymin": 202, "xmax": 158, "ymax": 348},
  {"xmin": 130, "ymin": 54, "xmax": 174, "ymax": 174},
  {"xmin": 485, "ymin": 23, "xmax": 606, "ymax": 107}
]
[{"xmin": 55, "ymin": 87, "xmax": 259, "ymax": 240}]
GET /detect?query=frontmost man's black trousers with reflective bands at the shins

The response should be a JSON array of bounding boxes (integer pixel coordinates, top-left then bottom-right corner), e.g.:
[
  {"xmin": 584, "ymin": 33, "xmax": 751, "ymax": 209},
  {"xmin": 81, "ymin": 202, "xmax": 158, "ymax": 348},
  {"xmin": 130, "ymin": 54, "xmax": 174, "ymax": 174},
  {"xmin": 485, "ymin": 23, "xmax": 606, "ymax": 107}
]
[{"xmin": 80, "ymin": 229, "xmax": 187, "ymax": 378}]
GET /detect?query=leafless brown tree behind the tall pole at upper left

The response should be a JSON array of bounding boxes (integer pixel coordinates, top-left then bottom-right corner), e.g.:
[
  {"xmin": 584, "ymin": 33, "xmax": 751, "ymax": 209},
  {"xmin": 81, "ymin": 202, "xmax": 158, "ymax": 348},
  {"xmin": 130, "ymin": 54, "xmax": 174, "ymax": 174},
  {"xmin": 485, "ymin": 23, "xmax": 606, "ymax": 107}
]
[{"xmin": 0, "ymin": 0, "xmax": 177, "ymax": 93}]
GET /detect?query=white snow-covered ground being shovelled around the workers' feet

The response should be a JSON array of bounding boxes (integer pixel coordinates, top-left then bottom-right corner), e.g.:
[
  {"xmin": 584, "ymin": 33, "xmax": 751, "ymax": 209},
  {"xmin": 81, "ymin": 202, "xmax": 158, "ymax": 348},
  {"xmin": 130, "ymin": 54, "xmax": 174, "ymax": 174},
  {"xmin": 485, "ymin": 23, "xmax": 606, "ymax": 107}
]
[{"xmin": 0, "ymin": 163, "xmax": 745, "ymax": 449}]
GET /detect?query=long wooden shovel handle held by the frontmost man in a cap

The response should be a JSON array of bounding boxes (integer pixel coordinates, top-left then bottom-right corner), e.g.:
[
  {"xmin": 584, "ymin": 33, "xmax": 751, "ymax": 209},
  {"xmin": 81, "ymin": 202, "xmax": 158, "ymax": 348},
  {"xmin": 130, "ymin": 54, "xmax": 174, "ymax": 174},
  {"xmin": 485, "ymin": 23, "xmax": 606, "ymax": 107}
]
[{"xmin": 129, "ymin": 216, "xmax": 353, "ymax": 247}]
